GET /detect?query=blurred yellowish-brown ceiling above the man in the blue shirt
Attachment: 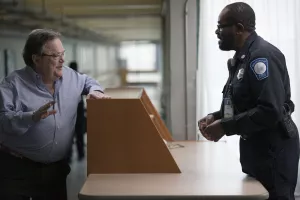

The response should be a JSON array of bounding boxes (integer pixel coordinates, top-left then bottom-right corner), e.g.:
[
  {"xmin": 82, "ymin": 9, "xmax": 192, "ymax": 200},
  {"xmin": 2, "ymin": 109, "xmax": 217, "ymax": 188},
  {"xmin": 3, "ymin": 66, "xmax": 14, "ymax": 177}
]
[{"xmin": 0, "ymin": 0, "xmax": 163, "ymax": 41}]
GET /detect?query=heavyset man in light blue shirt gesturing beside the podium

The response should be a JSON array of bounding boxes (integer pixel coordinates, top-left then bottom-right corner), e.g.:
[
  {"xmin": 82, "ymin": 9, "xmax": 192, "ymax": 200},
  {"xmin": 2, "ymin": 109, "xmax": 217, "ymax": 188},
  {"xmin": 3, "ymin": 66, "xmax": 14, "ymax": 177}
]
[{"xmin": 0, "ymin": 29, "xmax": 109, "ymax": 200}]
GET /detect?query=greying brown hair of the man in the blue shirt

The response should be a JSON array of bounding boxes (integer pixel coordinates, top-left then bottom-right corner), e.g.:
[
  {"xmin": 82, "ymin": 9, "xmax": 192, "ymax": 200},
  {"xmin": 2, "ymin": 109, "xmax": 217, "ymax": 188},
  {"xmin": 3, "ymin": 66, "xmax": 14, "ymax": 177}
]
[{"xmin": 23, "ymin": 29, "xmax": 61, "ymax": 67}]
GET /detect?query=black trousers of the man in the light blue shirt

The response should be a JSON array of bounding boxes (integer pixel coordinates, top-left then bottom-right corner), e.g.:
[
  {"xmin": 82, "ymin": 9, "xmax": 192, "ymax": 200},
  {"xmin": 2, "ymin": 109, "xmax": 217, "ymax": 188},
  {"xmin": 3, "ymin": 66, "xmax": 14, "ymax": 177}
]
[{"xmin": 0, "ymin": 152, "xmax": 70, "ymax": 200}]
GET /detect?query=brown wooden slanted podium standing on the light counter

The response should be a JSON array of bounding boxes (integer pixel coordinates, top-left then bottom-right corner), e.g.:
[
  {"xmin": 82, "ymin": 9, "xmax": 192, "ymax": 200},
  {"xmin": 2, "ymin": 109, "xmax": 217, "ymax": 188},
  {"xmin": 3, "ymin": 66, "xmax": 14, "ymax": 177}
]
[{"xmin": 87, "ymin": 88, "xmax": 180, "ymax": 174}]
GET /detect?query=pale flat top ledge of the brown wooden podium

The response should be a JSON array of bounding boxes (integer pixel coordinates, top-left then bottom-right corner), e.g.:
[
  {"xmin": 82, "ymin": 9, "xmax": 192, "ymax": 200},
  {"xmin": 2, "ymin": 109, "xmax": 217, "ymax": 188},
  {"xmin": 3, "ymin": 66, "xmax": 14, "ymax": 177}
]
[{"xmin": 104, "ymin": 87, "xmax": 143, "ymax": 99}]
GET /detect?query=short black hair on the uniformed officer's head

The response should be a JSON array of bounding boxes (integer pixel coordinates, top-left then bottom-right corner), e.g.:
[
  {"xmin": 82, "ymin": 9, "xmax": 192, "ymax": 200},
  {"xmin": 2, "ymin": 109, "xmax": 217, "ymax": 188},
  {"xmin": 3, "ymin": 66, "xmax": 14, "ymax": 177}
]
[{"xmin": 225, "ymin": 2, "xmax": 255, "ymax": 32}]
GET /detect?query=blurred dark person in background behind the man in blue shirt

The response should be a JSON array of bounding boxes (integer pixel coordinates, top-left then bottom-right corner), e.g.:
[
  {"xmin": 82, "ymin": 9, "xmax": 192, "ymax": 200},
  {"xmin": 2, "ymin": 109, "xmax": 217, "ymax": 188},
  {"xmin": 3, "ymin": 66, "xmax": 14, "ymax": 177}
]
[{"xmin": 69, "ymin": 61, "xmax": 86, "ymax": 161}]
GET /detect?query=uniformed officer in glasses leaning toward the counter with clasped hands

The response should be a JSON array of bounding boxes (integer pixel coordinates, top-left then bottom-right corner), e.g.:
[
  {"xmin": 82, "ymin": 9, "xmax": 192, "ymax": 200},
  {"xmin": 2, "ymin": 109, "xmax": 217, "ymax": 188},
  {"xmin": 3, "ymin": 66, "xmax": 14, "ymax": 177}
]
[{"xmin": 198, "ymin": 2, "xmax": 299, "ymax": 200}]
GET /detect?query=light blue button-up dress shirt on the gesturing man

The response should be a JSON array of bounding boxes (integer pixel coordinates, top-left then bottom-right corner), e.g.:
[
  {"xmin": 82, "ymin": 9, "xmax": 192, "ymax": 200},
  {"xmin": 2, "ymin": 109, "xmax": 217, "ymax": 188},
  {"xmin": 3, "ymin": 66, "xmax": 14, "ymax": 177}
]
[{"xmin": 0, "ymin": 67, "xmax": 103, "ymax": 163}]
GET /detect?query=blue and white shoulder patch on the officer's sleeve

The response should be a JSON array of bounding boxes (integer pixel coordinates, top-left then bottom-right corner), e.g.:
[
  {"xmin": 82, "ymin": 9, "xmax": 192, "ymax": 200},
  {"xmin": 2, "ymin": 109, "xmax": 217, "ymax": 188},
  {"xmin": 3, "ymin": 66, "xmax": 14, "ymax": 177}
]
[{"xmin": 250, "ymin": 58, "xmax": 269, "ymax": 80}]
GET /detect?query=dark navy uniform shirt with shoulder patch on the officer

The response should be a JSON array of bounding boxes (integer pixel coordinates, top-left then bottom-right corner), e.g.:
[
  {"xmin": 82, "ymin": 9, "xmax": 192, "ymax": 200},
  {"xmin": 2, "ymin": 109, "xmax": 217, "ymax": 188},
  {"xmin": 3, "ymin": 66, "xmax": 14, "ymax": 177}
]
[{"xmin": 214, "ymin": 32, "xmax": 294, "ymax": 138}]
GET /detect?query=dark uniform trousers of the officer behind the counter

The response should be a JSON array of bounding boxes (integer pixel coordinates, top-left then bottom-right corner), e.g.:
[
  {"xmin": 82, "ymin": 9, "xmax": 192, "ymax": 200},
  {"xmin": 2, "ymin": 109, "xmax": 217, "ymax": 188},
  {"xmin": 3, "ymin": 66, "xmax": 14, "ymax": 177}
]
[{"xmin": 240, "ymin": 131, "xmax": 299, "ymax": 200}]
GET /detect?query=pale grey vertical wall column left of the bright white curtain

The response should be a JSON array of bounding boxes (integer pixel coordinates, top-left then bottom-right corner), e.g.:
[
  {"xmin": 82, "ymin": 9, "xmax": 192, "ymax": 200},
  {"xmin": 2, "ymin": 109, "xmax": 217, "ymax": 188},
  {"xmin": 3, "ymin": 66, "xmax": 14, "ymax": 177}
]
[{"xmin": 163, "ymin": 0, "xmax": 197, "ymax": 140}]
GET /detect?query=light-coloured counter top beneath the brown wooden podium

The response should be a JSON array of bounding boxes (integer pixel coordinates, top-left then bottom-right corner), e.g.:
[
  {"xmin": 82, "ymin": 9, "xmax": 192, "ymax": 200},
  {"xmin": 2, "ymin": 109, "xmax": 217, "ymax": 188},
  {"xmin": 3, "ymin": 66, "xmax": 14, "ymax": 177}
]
[{"xmin": 79, "ymin": 142, "xmax": 268, "ymax": 200}]
